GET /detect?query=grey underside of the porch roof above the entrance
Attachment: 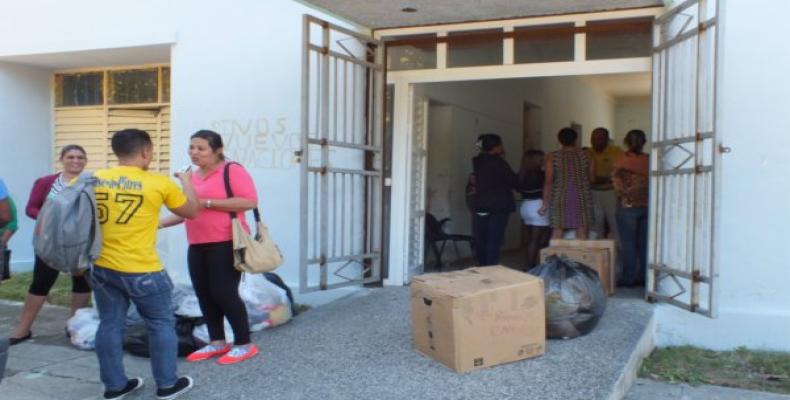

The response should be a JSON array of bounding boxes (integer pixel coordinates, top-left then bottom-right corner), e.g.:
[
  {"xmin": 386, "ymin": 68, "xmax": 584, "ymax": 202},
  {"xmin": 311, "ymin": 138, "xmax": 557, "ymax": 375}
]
[{"xmin": 305, "ymin": 0, "xmax": 664, "ymax": 29}]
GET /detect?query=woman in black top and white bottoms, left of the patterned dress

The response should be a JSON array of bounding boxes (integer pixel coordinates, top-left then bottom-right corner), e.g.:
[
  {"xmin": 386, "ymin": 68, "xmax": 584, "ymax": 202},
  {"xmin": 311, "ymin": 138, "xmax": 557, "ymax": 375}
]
[{"xmin": 518, "ymin": 150, "xmax": 551, "ymax": 271}]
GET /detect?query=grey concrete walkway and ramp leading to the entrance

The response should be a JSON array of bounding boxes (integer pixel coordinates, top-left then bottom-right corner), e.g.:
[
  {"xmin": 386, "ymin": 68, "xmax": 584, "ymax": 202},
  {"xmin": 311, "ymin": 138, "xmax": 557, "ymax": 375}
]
[{"xmin": 0, "ymin": 288, "xmax": 653, "ymax": 400}]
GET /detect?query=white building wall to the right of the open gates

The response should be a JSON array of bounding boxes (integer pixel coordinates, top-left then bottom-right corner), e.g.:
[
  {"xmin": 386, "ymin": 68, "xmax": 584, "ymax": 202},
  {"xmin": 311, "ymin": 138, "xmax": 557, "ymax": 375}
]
[{"xmin": 657, "ymin": 0, "xmax": 790, "ymax": 351}]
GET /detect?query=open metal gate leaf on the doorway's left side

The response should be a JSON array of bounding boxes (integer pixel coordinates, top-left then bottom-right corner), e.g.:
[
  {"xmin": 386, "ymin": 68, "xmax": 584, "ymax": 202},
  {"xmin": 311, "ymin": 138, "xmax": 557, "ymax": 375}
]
[{"xmin": 297, "ymin": 15, "xmax": 384, "ymax": 293}]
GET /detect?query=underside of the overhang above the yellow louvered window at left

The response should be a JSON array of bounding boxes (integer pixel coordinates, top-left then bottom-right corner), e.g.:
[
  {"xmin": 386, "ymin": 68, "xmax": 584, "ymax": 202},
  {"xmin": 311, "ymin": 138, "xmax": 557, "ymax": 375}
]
[{"xmin": 0, "ymin": 44, "xmax": 170, "ymax": 69}]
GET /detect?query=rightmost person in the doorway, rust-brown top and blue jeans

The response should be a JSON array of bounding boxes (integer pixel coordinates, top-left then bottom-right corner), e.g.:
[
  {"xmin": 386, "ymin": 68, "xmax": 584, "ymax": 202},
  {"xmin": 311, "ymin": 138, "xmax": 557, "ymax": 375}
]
[{"xmin": 612, "ymin": 129, "xmax": 650, "ymax": 286}]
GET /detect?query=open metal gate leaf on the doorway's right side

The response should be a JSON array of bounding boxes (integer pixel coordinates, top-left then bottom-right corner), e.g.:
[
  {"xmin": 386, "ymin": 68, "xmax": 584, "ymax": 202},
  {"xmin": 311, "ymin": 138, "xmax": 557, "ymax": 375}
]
[{"xmin": 647, "ymin": 0, "xmax": 726, "ymax": 317}]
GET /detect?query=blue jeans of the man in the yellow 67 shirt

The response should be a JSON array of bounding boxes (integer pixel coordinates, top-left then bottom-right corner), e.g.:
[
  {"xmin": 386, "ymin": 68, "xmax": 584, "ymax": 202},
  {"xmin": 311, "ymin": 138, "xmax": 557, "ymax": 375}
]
[{"xmin": 88, "ymin": 266, "xmax": 178, "ymax": 390}]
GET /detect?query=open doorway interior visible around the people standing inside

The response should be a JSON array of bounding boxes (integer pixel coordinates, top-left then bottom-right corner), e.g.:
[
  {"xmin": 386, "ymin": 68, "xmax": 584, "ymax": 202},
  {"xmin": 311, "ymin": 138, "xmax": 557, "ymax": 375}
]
[{"xmin": 410, "ymin": 73, "xmax": 651, "ymax": 271}]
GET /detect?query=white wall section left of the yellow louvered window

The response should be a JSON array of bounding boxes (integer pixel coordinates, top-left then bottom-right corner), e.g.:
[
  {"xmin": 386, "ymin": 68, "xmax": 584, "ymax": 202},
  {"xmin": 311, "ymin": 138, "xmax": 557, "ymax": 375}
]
[{"xmin": 0, "ymin": 62, "xmax": 52, "ymax": 272}]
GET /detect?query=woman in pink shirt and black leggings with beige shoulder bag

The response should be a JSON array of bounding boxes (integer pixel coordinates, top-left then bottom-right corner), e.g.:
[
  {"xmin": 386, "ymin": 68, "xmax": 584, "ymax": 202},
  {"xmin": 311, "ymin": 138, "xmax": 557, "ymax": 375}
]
[{"xmin": 161, "ymin": 130, "xmax": 258, "ymax": 364}]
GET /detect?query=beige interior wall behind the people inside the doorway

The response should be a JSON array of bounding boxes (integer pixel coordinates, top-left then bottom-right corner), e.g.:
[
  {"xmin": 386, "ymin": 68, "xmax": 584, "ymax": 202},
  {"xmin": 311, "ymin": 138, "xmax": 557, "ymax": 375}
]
[{"xmin": 425, "ymin": 77, "xmax": 615, "ymax": 262}]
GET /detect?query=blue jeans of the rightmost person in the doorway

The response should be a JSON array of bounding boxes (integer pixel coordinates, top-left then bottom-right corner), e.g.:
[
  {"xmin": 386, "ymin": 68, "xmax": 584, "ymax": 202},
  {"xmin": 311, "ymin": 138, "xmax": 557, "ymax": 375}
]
[{"xmin": 617, "ymin": 207, "xmax": 647, "ymax": 286}]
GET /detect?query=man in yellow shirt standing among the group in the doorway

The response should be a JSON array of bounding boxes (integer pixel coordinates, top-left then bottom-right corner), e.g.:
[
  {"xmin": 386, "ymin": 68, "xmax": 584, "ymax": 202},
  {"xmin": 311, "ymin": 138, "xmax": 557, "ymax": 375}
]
[{"xmin": 590, "ymin": 128, "xmax": 623, "ymax": 240}]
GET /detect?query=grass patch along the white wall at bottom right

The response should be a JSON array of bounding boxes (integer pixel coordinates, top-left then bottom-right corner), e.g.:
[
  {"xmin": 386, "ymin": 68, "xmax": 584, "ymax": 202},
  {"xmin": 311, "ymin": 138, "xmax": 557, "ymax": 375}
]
[{"xmin": 639, "ymin": 346, "xmax": 790, "ymax": 394}]
